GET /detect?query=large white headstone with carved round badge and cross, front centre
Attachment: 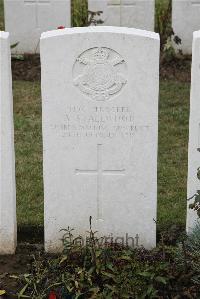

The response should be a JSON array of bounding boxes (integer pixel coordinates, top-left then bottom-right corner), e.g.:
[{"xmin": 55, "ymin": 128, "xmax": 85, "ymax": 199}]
[{"xmin": 41, "ymin": 26, "xmax": 159, "ymax": 252}]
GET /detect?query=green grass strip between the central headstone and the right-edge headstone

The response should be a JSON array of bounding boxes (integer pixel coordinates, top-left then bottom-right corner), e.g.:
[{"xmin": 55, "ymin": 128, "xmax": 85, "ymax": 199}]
[{"xmin": 158, "ymin": 81, "xmax": 190, "ymax": 227}]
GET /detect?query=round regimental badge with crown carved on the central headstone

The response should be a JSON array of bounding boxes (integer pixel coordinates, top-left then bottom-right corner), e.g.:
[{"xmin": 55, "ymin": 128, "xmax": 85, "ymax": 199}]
[{"xmin": 73, "ymin": 47, "xmax": 127, "ymax": 101}]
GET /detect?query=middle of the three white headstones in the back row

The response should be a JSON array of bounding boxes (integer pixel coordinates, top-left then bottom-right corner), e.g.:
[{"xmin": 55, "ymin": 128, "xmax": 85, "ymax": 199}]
[{"xmin": 88, "ymin": 0, "xmax": 155, "ymax": 31}]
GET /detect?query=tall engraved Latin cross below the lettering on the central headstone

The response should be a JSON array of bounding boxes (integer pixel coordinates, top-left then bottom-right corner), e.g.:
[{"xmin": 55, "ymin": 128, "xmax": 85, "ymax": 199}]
[{"xmin": 75, "ymin": 144, "xmax": 125, "ymax": 220}]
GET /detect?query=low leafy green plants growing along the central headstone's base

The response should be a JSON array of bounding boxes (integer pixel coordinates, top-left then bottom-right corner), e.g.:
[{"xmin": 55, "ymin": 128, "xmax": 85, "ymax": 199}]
[{"xmin": 15, "ymin": 227, "xmax": 200, "ymax": 299}]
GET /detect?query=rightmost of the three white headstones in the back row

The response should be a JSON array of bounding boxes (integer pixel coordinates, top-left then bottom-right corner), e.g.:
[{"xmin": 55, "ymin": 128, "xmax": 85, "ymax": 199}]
[{"xmin": 172, "ymin": 0, "xmax": 200, "ymax": 54}]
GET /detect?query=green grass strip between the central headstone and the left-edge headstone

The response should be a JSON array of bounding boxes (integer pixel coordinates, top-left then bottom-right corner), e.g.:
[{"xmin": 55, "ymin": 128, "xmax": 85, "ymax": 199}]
[{"xmin": 13, "ymin": 81, "xmax": 43, "ymax": 225}]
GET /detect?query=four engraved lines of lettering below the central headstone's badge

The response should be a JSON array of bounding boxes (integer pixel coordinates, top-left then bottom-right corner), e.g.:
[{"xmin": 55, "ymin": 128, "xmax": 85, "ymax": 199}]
[{"xmin": 52, "ymin": 106, "xmax": 149, "ymax": 139}]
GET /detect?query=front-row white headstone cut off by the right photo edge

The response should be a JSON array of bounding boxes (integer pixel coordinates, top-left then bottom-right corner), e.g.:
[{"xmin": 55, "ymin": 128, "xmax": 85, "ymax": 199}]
[{"xmin": 187, "ymin": 31, "xmax": 200, "ymax": 231}]
